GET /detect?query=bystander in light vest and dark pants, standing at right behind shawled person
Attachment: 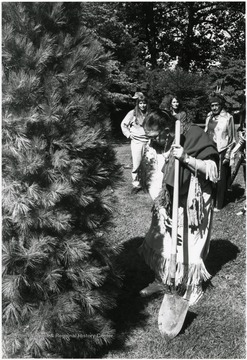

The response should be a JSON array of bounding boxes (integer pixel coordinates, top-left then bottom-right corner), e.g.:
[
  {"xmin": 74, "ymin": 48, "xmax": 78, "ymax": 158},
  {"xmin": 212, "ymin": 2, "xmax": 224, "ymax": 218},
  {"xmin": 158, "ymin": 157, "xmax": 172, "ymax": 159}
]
[{"xmin": 204, "ymin": 94, "xmax": 235, "ymax": 212}]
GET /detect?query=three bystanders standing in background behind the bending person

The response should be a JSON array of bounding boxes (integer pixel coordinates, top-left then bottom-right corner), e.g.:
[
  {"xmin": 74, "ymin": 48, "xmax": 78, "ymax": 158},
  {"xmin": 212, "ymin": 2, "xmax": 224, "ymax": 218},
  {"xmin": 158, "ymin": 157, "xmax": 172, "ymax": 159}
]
[{"xmin": 121, "ymin": 92, "xmax": 236, "ymax": 212}]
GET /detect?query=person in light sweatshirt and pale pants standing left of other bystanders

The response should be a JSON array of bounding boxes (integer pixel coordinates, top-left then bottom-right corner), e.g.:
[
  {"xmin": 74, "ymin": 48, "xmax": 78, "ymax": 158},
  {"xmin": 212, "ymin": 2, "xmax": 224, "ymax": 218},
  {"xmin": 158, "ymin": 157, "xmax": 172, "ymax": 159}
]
[{"xmin": 121, "ymin": 92, "xmax": 148, "ymax": 194}]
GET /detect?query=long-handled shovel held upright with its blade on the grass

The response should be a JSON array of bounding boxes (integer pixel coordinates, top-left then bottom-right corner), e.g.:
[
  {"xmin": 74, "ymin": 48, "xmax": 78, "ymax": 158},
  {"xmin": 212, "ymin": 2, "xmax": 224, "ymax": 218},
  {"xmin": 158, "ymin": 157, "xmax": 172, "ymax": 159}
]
[{"xmin": 158, "ymin": 120, "xmax": 189, "ymax": 339}]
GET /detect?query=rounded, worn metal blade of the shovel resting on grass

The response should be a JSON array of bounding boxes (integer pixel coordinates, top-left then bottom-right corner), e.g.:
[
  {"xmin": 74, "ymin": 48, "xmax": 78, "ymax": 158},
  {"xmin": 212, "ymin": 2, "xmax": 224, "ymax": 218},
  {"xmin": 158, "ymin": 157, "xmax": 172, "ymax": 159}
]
[{"xmin": 158, "ymin": 293, "xmax": 189, "ymax": 339}]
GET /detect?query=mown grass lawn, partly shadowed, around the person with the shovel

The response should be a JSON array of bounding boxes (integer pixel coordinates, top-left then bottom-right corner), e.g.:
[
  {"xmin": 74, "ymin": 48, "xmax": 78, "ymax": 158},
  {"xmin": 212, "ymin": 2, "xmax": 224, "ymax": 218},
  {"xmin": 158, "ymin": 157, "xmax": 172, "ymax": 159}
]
[{"xmin": 100, "ymin": 143, "xmax": 246, "ymax": 359}]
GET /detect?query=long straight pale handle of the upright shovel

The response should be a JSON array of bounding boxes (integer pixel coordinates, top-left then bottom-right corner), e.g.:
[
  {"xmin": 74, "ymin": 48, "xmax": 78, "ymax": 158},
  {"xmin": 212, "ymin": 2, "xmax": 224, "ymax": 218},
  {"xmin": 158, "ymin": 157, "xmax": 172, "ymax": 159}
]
[{"xmin": 170, "ymin": 120, "xmax": 180, "ymax": 279}]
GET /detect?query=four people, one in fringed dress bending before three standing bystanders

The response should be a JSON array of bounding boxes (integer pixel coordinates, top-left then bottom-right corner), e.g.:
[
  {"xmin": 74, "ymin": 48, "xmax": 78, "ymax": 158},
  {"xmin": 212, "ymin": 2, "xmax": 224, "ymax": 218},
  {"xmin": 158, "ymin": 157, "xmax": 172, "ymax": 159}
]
[{"xmin": 121, "ymin": 93, "xmax": 244, "ymax": 305}]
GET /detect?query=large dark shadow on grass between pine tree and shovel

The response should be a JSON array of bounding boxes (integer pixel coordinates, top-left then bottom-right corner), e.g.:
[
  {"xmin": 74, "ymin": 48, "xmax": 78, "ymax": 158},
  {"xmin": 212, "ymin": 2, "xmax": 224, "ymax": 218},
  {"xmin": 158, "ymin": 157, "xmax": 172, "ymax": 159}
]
[{"xmin": 96, "ymin": 237, "xmax": 154, "ymax": 356}]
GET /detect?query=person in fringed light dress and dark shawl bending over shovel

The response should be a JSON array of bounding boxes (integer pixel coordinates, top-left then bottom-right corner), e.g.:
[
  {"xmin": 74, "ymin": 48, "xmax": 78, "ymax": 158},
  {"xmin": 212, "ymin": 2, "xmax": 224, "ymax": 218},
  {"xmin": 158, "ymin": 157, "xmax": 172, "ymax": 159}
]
[{"xmin": 139, "ymin": 111, "xmax": 218, "ymax": 306}]
